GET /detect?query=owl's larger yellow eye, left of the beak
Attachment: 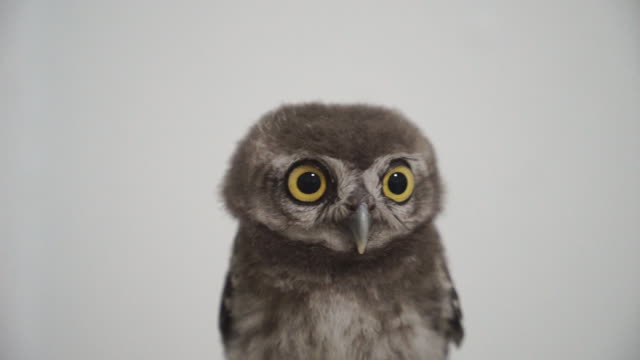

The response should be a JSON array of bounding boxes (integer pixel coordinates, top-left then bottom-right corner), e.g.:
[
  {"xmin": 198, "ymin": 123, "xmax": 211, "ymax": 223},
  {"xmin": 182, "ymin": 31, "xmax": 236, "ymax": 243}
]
[{"xmin": 287, "ymin": 165, "xmax": 327, "ymax": 202}]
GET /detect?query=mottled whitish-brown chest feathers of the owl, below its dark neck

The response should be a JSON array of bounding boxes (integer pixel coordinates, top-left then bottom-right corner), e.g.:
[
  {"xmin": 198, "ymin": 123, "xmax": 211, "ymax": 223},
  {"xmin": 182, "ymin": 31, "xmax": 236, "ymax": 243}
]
[{"xmin": 227, "ymin": 290, "xmax": 447, "ymax": 360}]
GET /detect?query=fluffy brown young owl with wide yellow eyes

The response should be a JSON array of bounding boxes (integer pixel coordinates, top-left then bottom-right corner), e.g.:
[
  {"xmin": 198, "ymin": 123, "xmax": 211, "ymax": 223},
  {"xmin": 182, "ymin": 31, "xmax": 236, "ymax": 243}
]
[{"xmin": 219, "ymin": 103, "xmax": 463, "ymax": 360}]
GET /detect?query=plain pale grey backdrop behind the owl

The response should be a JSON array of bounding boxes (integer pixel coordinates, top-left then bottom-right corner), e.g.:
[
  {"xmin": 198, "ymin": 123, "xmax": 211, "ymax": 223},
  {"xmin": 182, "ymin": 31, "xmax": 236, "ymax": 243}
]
[{"xmin": 0, "ymin": 0, "xmax": 640, "ymax": 360}]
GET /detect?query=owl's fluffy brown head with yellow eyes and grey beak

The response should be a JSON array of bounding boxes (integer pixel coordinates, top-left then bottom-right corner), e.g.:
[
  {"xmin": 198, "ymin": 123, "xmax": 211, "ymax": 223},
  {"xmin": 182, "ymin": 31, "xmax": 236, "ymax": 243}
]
[{"xmin": 224, "ymin": 103, "xmax": 441, "ymax": 254}]
